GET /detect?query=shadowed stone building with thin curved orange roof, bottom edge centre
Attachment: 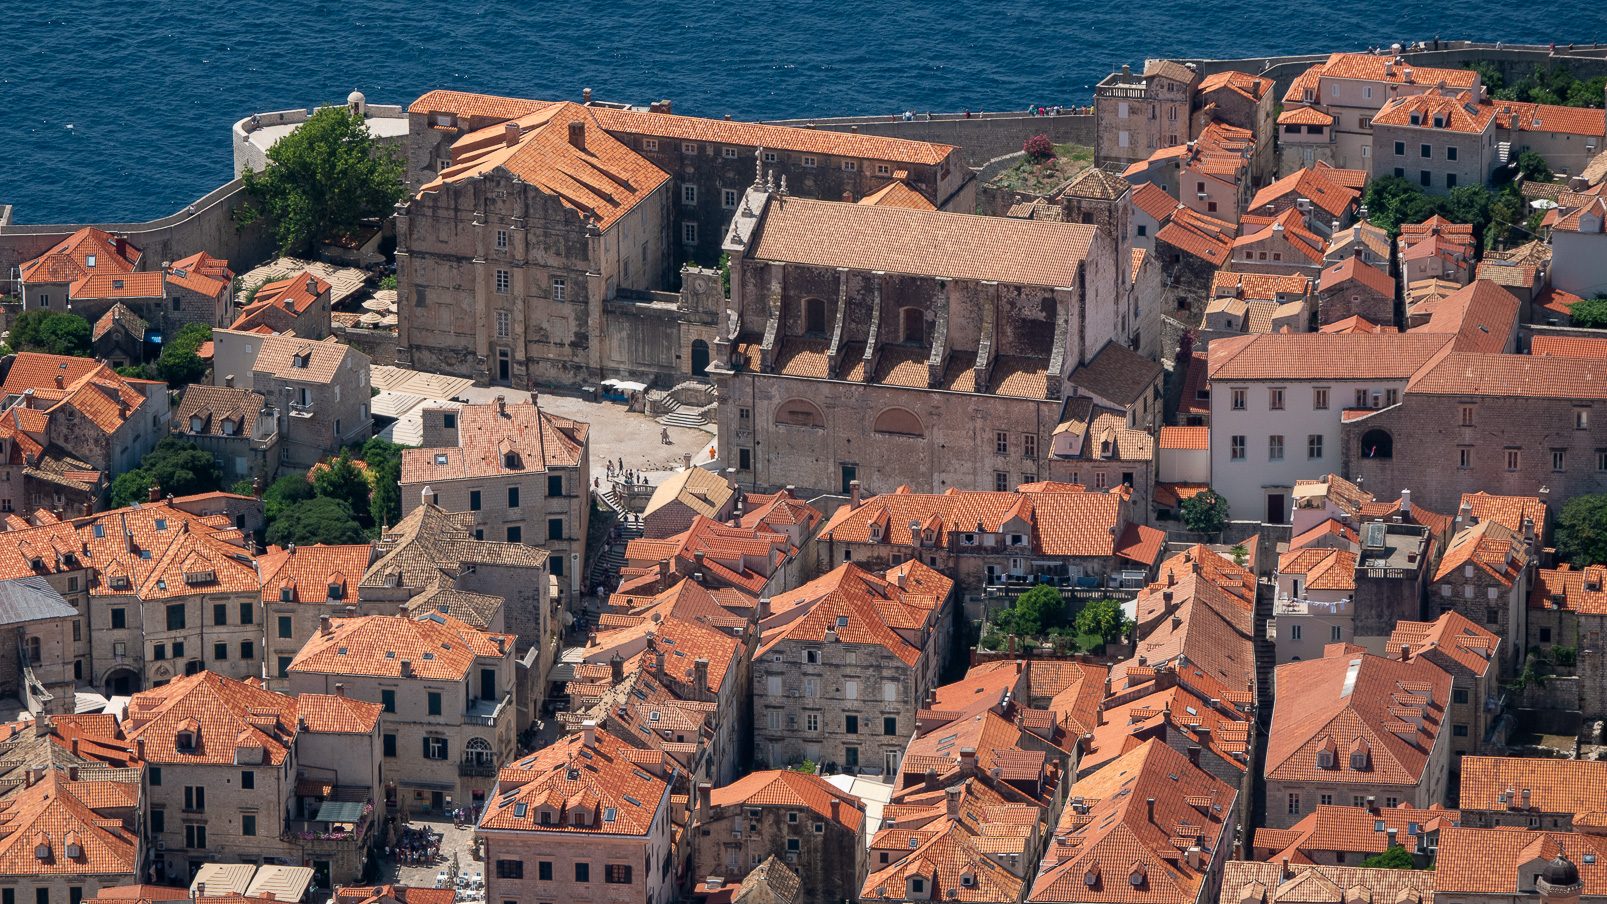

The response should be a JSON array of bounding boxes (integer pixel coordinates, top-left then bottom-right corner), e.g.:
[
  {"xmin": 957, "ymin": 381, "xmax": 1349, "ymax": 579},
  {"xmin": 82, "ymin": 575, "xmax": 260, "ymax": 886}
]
[{"xmin": 688, "ymin": 769, "xmax": 868, "ymax": 904}]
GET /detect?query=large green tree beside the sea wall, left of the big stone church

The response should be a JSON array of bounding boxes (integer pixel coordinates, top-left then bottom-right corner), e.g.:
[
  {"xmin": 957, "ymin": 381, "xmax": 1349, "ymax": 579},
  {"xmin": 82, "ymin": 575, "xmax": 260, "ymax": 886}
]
[{"xmin": 236, "ymin": 106, "xmax": 407, "ymax": 254}]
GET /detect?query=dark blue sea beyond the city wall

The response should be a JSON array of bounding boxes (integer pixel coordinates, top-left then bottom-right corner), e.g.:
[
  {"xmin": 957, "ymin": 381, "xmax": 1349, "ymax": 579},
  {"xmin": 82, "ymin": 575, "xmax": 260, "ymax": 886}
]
[{"xmin": 0, "ymin": 0, "xmax": 1607, "ymax": 223}]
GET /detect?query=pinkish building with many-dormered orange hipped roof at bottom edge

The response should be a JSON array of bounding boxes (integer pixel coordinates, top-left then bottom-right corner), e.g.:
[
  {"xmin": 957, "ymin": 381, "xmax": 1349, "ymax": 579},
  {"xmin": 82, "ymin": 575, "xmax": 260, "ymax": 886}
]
[{"xmin": 477, "ymin": 724, "xmax": 686, "ymax": 904}]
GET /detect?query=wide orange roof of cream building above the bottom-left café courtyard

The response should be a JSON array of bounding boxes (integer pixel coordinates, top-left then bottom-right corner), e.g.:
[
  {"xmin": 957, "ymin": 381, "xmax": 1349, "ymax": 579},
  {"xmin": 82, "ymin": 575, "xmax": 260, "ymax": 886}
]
[{"xmin": 289, "ymin": 613, "xmax": 514, "ymax": 681}]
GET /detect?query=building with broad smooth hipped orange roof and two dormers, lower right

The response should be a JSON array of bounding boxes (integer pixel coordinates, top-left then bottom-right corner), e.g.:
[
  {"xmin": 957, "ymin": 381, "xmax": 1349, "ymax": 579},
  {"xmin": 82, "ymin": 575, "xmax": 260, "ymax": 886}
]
[{"xmin": 1263, "ymin": 644, "xmax": 1451, "ymax": 829}]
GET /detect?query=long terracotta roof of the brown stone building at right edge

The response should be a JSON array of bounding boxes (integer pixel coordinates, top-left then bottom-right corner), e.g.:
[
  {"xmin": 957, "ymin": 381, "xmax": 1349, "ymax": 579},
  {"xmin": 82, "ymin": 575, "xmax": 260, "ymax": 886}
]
[{"xmin": 1403, "ymin": 351, "xmax": 1607, "ymax": 400}]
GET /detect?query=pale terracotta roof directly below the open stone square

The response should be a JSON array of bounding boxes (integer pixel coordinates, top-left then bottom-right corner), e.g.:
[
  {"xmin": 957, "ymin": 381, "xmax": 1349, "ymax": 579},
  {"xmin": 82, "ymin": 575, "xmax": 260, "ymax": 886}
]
[{"xmin": 402, "ymin": 401, "xmax": 591, "ymax": 487}]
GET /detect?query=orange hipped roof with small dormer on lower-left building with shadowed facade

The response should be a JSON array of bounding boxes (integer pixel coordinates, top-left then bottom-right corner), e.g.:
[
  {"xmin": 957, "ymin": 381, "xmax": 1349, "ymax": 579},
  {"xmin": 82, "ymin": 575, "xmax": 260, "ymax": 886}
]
[{"xmin": 125, "ymin": 671, "xmax": 297, "ymax": 766}]
